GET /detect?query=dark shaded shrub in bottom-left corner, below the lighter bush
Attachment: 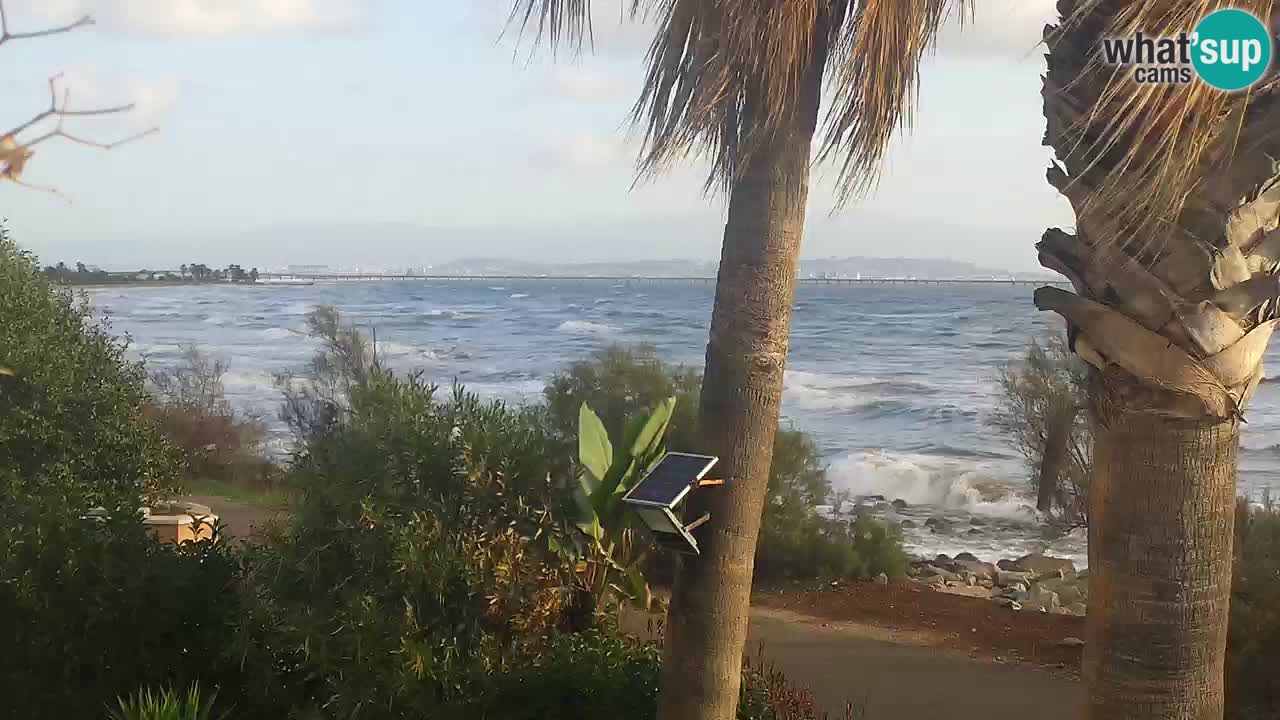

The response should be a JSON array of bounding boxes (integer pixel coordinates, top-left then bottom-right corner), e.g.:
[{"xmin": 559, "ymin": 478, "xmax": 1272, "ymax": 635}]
[{"xmin": 0, "ymin": 504, "xmax": 241, "ymax": 717}]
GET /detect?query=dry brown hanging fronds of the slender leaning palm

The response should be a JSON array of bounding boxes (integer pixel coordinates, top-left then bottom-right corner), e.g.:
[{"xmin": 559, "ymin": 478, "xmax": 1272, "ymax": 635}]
[{"xmin": 512, "ymin": 0, "xmax": 972, "ymax": 196}]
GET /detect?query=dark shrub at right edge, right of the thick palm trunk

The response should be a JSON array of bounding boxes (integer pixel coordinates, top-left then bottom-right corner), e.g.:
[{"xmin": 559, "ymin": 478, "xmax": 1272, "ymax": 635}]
[{"xmin": 1226, "ymin": 501, "xmax": 1280, "ymax": 720}]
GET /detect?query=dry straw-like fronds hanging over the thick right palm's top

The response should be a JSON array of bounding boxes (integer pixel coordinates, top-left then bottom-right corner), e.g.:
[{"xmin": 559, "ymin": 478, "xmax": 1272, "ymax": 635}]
[{"xmin": 1048, "ymin": 0, "xmax": 1271, "ymax": 256}]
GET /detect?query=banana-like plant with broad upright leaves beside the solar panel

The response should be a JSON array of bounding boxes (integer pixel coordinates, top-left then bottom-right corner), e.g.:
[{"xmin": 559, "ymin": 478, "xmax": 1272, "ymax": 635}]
[{"xmin": 573, "ymin": 397, "xmax": 676, "ymax": 615}]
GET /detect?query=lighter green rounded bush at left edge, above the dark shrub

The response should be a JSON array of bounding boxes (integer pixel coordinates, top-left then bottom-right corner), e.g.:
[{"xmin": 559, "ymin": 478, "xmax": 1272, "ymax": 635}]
[{"xmin": 0, "ymin": 227, "xmax": 180, "ymax": 509}]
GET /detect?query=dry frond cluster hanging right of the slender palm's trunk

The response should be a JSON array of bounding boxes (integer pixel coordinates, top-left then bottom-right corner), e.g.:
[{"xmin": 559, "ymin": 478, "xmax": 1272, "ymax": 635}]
[{"xmin": 822, "ymin": 0, "xmax": 973, "ymax": 200}]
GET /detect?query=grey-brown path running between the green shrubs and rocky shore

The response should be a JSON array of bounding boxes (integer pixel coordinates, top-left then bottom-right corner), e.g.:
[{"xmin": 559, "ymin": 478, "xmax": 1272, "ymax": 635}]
[{"xmin": 192, "ymin": 497, "xmax": 1084, "ymax": 720}]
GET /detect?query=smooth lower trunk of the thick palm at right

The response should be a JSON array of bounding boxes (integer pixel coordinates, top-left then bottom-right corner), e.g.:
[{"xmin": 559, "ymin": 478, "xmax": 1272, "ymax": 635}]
[{"xmin": 1084, "ymin": 394, "xmax": 1239, "ymax": 720}]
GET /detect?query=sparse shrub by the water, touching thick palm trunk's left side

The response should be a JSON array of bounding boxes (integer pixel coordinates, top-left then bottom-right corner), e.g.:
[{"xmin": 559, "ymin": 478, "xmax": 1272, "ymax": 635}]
[{"xmin": 992, "ymin": 334, "xmax": 1093, "ymax": 527}]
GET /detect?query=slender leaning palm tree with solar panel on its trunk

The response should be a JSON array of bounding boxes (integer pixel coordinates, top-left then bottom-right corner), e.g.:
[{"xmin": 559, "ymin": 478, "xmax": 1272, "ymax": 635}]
[{"xmin": 513, "ymin": 0, "xmax": 966, "ymax": 720}]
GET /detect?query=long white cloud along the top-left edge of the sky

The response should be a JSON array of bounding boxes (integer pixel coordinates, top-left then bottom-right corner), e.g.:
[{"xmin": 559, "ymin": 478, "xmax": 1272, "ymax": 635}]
[{"xmin": 15, "ymin": 0, "xmax": 367, "ymax": 35}]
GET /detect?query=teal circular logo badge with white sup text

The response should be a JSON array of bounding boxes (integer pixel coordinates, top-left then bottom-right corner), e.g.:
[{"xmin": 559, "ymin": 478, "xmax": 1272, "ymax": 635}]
[{"xmin": 1192, "ymin": 8, "xmax": 1272, "ymax": 92}]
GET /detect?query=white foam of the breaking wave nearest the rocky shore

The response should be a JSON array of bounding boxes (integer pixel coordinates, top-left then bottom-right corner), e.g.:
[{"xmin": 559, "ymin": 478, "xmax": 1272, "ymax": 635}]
[{"xmin": 827, "ymin": 451, "xmax": 1037, "ymax": 520}]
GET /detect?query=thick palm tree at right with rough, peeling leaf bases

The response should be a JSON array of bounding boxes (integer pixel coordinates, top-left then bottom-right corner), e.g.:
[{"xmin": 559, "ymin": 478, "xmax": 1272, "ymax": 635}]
[{"xmin": 1036, "ymin": 0, "xmax": 1280, "ymax": 720}]
